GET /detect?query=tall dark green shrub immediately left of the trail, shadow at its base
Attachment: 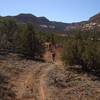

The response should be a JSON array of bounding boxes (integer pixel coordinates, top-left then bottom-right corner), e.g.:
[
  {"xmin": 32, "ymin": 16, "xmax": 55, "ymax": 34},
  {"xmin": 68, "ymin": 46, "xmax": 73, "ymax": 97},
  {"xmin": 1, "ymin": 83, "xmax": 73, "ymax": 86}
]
[{"xmin": 16, "ymin": 24, "xmax": 44, "ymax": 58}]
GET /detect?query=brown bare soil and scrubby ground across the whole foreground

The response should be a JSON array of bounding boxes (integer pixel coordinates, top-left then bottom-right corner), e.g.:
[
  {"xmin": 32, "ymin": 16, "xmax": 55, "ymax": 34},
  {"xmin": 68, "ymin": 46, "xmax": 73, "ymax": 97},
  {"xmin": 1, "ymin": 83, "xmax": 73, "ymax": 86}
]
[{"xmin": 0, "ymin": 54, "xmax": 100, "ymax": 100}]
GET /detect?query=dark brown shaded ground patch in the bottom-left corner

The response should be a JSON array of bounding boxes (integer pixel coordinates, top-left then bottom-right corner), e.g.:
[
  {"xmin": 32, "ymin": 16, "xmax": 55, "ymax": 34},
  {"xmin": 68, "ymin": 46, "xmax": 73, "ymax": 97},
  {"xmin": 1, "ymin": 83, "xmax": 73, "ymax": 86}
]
[{"xmin": 0, "ymin": 72, "xmax": 16, "ymax": 100}]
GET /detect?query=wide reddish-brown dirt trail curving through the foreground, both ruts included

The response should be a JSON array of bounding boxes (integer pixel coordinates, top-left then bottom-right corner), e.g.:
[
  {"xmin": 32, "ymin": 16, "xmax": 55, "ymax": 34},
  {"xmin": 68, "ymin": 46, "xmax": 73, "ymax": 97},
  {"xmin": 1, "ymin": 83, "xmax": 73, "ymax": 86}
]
[{"xmin": 13, "ymin": 63, "xmax": 55, "ymax": 100}]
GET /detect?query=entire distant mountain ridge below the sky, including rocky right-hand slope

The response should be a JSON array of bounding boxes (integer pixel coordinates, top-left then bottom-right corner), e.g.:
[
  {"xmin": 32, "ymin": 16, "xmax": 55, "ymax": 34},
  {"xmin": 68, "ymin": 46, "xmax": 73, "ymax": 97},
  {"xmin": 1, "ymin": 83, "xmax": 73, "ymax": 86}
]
[{"xmin": 0, "ymin": 13, "xmax": 100, "ymax": 33}]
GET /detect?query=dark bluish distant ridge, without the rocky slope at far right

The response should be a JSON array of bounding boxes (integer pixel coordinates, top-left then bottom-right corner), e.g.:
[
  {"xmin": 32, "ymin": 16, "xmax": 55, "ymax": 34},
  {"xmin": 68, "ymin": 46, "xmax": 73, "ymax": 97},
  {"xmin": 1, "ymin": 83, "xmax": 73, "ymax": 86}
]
[{"xmin": 2, "ymin": 14, "xmax": 79, "ymax": 33}]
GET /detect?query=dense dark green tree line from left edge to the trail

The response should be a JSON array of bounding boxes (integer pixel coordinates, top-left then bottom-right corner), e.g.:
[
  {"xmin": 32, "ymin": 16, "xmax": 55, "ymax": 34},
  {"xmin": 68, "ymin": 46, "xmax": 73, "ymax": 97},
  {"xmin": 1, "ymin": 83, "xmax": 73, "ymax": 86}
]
[{"xmin": 0, "ymin": 19, "xmax": 45, "ymax": 58}]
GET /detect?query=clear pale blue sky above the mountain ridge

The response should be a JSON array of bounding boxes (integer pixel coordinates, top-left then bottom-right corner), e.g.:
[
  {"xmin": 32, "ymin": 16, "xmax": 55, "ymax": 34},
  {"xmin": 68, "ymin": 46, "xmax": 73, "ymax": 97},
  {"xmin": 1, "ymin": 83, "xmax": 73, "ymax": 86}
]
[{"xmin": 0, "ymin": 0, "xmax": 100, "ymax": 23}]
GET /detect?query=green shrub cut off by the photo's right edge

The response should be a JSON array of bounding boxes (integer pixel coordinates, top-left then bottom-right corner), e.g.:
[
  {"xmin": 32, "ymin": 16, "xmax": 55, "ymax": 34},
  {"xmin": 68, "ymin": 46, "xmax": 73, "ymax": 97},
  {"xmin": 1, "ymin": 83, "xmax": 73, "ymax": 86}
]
[{"xmin": 82, "ymin": 40, "xmax": 100, "ymax": 71}]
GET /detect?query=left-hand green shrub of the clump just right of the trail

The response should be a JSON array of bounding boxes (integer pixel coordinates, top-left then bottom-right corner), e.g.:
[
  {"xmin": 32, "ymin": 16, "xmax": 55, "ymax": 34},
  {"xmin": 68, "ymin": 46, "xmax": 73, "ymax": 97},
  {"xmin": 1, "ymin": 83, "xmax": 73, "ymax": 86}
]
[{"xmin": 62, "ymin": 36, "xmax": 84, "ymax": 65}]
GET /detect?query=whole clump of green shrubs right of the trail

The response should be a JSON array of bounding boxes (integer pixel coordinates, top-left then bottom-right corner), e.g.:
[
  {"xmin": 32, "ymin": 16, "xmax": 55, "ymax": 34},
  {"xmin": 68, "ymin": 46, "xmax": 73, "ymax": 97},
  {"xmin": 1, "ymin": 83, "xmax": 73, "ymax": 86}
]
[{"xmin": 62, "ymin": 34, "xmax": 100, "ymax": 71}]
